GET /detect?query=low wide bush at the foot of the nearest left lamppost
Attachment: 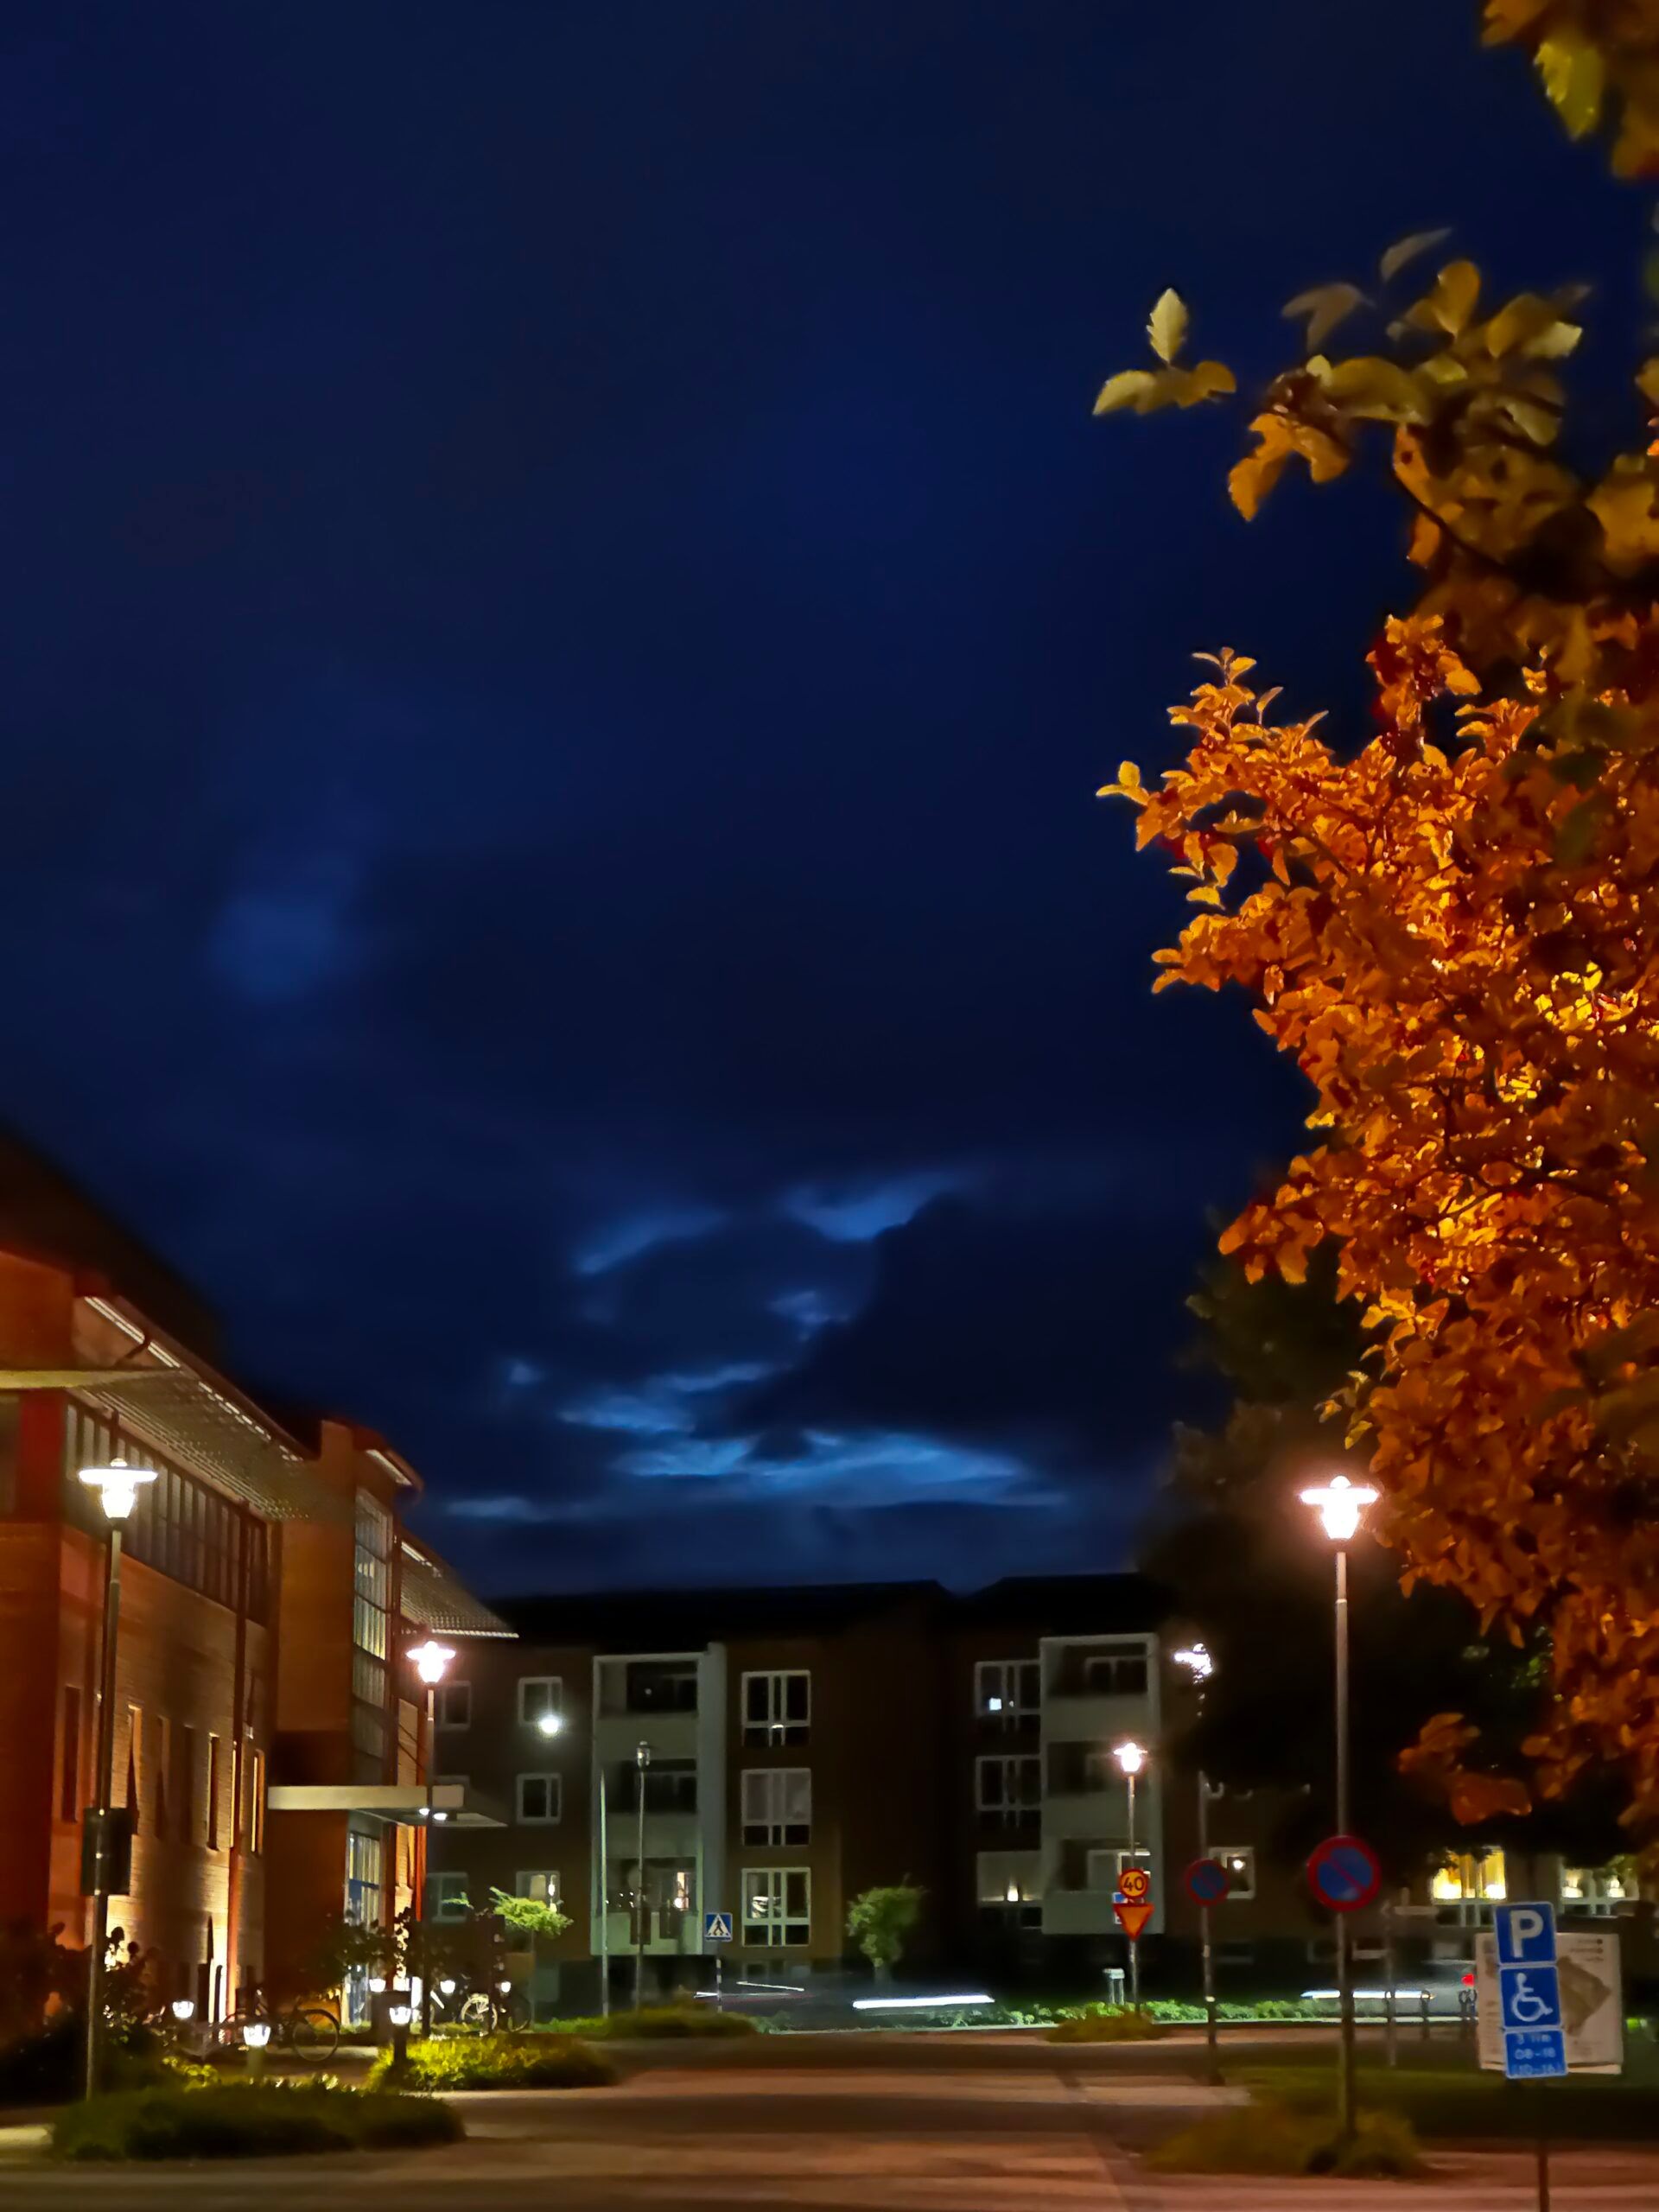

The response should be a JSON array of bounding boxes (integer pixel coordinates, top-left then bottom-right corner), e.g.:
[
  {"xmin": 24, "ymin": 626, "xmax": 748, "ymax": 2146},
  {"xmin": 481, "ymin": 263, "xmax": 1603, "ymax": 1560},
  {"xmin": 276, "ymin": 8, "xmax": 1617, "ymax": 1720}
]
[{"xmin": 51, "ymin": 2082, "xmax": 467, "ymax": 2159}]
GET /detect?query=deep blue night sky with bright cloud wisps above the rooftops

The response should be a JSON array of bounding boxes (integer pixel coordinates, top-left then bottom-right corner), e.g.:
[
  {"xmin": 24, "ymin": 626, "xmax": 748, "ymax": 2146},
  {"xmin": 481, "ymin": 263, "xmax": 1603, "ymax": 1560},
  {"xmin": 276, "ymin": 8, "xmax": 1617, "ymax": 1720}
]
[{"xmin": 0, "ymin": 0, "xmax": 1646, "ymax": 1591}]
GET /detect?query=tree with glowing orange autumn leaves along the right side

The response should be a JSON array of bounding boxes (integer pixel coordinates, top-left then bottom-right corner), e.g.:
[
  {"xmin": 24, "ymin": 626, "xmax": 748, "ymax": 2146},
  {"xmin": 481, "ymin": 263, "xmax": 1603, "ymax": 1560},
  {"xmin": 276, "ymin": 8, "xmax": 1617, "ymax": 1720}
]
[{"xmin": 1097, "ymin": 0, "xmax": 1659, "ymax": 1838}]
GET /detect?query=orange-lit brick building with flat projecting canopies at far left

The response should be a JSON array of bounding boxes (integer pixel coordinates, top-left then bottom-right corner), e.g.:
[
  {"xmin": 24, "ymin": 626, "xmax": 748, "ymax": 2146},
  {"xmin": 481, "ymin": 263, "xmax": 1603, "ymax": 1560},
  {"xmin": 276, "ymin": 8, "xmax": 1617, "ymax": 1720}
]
[{"xmin": 0, "ymin": 1141, "xmax": 505, "ymax": 2018}]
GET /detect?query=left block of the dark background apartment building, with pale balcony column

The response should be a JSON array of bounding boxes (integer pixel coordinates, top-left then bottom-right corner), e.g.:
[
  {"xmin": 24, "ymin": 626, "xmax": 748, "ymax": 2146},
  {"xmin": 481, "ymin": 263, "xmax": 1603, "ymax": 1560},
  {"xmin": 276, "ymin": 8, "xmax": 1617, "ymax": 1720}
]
[{"xmin": 429, "ymin": 1584, "xmax": 943, "ymax": 2008}]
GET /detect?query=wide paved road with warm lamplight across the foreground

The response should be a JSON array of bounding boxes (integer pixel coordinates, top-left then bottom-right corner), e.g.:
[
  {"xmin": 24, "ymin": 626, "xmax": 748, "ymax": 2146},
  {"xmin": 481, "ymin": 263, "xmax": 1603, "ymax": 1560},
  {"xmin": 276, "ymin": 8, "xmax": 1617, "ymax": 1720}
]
[{"xmin": 0, "ymin": 2037, "xmax": 1659, "ymax": 2212}]
